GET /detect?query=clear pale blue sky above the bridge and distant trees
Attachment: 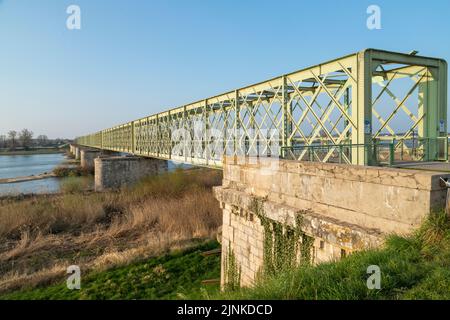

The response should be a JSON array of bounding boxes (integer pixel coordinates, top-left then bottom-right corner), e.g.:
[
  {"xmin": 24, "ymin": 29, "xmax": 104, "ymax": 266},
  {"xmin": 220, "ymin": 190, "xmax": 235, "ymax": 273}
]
[{"xmin": 0, "ymin": 0, "xmax": 450, "ymax": 138}]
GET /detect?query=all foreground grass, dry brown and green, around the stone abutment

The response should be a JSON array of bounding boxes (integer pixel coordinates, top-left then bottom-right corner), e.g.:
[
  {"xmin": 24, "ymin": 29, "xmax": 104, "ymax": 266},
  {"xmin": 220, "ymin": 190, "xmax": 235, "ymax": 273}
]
[{"xmin": 4, "ymin": 165, "xmax": 450, "ymax": 300}]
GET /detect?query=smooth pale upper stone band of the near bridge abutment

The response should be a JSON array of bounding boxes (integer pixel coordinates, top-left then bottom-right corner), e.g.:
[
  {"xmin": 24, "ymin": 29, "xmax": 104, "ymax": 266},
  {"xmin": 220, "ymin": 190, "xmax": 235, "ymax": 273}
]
[{"xmin": 223, "ymin": 158, "xmax": 450, "ymax": 233}]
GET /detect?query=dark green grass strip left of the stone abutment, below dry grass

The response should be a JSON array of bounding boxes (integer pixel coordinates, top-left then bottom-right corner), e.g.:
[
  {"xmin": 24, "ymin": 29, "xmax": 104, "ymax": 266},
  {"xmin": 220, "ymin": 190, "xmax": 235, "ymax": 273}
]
[{"xmin": 0, "ymin": 241, "xmax": 220, "ymax": 300}]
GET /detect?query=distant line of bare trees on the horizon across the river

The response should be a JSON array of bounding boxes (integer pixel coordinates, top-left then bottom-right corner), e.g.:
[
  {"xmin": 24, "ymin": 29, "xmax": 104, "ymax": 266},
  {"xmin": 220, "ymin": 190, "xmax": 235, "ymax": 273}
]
[{"xmin": 0, "ymin": 129, "xmax": 68, "ymax": 150}]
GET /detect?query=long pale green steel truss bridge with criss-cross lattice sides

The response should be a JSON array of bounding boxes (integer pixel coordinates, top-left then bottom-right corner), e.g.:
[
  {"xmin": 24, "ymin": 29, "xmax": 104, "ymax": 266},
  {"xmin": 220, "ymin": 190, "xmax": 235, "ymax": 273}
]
[{"xmin": 76, "ymin": 49, "xmax": 448, "ymax": 167}]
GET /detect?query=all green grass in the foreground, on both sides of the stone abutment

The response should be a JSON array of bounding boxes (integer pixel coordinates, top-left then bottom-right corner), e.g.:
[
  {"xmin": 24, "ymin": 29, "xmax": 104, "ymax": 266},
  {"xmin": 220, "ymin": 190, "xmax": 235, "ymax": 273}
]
[{"xmin": 5, "ymin": 213, "xmax": 450, "ymax": 300}]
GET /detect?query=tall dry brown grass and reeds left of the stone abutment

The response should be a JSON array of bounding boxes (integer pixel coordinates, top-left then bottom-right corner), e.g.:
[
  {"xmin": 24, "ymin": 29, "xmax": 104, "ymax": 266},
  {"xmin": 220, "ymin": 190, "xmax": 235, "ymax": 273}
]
[{"xmin": 0, "ymin": 169, "xmax": 221, "ymax": 294}]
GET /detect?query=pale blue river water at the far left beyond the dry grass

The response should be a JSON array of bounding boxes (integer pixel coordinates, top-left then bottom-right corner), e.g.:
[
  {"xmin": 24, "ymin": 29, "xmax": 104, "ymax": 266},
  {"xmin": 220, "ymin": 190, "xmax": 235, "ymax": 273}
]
[{"xmin": 0, "ymin": 153, "xmax": 64, "ymax": 196}]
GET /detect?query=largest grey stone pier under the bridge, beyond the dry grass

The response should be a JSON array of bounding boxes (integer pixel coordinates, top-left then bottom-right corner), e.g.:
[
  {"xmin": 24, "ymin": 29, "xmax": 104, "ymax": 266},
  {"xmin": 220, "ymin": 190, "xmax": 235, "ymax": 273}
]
[{"xmin": 94, "ymin": 157, "xmax": 168, "ymax": 191}]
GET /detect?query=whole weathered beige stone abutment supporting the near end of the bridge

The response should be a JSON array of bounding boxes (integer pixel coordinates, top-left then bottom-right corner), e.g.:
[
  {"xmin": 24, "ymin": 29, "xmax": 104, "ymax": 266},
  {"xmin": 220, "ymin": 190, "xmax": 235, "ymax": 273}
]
[{"xmin": 214, "ymin": 157, "xmax": 450, "ymax": 286}]
